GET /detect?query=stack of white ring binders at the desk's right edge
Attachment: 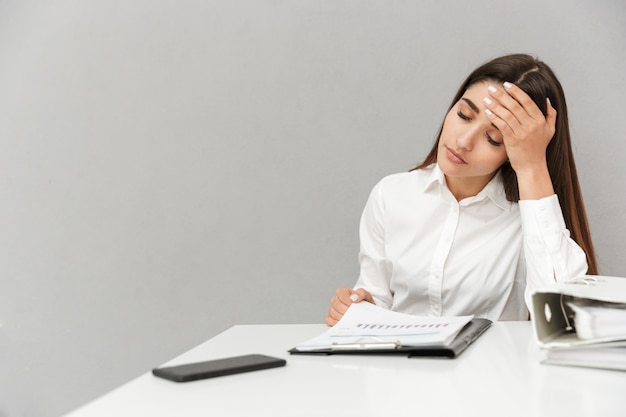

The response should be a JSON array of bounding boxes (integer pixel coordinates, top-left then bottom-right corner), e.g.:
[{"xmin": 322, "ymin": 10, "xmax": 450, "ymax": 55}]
[{"xmin": 532, "ymin": 275, "xmax": 626, "ymax": 371}]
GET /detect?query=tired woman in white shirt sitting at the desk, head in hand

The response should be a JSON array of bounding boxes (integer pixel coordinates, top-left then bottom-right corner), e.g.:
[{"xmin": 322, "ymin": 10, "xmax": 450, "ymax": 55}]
[{"xmin": 326, "ymin": 54, "xmax": 597, "ymax": 326}]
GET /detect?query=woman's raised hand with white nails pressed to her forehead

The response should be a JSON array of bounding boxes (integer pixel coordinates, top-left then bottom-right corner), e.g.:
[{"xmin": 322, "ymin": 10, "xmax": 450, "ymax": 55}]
[{"xmin": 485, "ymin": 83, "xmax": 556, "ymax": 175}]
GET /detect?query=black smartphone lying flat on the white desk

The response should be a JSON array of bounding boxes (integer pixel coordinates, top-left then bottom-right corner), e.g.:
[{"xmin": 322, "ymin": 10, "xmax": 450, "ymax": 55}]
[{"xmin": 152, "ymin": 354, "xmax": 287, "ymax": 382}]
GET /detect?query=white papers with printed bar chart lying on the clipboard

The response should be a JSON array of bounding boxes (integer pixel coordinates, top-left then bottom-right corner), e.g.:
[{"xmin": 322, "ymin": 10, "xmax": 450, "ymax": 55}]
[{"xmin": 295, "ymin": 302, "xmax": 473, "ymax": 352}]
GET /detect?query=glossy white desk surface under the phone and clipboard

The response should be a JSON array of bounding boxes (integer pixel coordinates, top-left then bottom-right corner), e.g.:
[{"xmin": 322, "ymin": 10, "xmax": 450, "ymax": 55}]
[{"xmin": 67, "ymin": 322, "xmax": 626, "ymax": 417}]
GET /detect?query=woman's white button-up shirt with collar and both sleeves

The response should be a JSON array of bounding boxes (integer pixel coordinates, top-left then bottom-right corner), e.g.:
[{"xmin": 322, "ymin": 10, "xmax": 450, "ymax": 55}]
[{"xmin": 355, "ymin": 164, "xmax": 587, "ymax": 320}]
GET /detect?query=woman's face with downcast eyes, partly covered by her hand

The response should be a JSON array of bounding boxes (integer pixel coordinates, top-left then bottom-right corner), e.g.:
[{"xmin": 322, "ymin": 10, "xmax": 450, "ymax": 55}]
[{"xmin": 437, "ymin": 82, "xmax": 507, "ymax": 195}]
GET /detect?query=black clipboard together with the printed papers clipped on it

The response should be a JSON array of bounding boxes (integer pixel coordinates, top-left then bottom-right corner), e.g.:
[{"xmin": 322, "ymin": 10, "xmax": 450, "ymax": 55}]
[{"xmin": 289, "ymin": 302, "xmax": 491, "ymax": 358}]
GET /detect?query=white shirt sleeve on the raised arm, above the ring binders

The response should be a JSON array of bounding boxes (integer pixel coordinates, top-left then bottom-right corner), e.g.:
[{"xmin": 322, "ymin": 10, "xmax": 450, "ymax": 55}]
[{"xmin": 519, "ymin": 194, "xmax": 587, "ymax": 311}]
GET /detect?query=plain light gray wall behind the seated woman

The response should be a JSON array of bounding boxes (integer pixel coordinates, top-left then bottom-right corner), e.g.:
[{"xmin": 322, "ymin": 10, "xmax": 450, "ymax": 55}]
[{"xmin": 0, "ymin": 0, "xmax": 626, "ymax": 417}]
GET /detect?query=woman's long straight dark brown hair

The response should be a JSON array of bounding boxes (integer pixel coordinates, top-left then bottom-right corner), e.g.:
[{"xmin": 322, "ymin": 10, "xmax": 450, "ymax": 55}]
[{"xmin": 413, "ymin": 54, "xmax": 598, "ymax": 275}]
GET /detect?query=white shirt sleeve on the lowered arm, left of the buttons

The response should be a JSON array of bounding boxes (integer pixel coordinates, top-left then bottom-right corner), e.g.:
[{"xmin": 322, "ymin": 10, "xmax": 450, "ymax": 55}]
[{"xmin": 354, "ymin": 180, "xmax": 393, "ymax": 308}]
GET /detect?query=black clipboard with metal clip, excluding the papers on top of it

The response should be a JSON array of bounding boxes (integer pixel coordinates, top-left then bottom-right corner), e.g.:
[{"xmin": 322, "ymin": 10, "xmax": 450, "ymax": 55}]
[{"xmin": 288, "ymin": 318, "xmax": 493, "ymax": 359}]
